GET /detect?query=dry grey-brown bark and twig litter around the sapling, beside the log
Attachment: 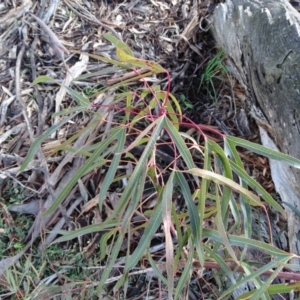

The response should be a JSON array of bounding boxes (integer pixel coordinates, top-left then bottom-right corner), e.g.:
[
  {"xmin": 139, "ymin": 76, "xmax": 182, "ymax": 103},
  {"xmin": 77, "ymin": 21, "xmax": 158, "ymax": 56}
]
[{"xmin": 0, "ymin": 0, "xmax": 292, "ymax": 299}]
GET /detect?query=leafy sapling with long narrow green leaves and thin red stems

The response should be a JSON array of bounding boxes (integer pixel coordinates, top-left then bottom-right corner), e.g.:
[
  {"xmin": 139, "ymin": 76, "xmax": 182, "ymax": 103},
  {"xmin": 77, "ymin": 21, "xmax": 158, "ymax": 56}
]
[{"xmin": 6, "ymin": 35, "xmax": 300, "ymax": 299}]
